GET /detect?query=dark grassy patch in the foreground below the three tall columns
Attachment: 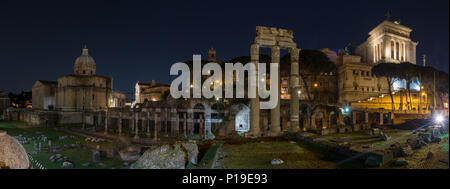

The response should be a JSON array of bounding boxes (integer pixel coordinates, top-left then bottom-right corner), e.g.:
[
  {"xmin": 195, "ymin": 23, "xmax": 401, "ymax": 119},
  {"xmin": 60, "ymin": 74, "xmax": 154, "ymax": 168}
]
[{"xmin": 220, "ymin": 138, "xmax": 363, "ymax": 169}]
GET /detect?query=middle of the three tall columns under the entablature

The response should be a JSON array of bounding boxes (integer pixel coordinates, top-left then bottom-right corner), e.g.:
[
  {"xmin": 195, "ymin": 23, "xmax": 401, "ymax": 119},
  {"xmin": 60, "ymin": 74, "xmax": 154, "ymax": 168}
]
[{"xmin": 270, "ymin": 46, "xmax": 280, "ymax": 136}]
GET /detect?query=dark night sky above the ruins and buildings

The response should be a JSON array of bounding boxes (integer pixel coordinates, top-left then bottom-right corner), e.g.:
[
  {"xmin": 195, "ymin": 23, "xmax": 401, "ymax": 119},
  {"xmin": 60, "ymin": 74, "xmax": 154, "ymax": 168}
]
[{"xmin": 0, "ymin": 0, "xmax": 449, "ymax": 97}]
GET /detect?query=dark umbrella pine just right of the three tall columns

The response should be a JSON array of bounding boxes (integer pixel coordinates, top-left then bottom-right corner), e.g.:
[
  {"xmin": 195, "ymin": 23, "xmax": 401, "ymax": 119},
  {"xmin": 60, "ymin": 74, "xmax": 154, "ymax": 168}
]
[{"xmin": 280, "ymin": 50, "xmax": 337, "ymax": 127}]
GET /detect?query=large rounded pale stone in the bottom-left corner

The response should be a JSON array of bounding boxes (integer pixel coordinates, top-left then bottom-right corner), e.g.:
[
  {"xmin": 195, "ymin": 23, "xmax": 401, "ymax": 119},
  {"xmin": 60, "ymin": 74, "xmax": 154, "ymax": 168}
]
[{"xmin": 0, "ymin": 130, "xmax": 31, "ymax": 169}]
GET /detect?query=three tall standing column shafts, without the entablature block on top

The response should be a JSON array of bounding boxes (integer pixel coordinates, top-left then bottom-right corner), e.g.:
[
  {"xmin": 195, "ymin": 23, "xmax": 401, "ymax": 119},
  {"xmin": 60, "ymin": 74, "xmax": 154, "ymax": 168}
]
[{"xmin": 250, "ymin": 44, "xmax": 300, "ymax": 136}]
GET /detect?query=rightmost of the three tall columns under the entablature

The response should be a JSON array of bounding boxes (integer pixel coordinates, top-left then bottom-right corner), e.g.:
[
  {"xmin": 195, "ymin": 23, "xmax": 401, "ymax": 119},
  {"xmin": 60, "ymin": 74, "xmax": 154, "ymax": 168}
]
[{"xmin": 290, "ymin": 48, "xmax": 300, "ymax": 133}]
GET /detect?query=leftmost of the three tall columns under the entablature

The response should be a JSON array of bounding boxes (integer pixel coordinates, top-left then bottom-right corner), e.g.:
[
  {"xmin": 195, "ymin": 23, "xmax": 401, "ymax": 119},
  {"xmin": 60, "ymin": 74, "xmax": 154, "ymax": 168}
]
[{"xmin": 250, "ymin": 44, "xmax": 260, "ymax": 137}]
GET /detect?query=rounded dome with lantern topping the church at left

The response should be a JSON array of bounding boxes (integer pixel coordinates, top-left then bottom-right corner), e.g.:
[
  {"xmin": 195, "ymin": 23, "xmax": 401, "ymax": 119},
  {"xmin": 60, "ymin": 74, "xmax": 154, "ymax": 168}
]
[{"xmin": 73, "ymin": 45, "xmax": 96, "ymax": 75}]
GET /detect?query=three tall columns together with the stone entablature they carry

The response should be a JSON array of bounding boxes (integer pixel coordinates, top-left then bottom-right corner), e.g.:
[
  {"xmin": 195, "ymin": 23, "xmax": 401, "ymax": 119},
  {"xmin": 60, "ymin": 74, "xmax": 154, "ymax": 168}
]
[{"xmin": 250, "ymin": 26, "xmax": 300, "ymax": 137}]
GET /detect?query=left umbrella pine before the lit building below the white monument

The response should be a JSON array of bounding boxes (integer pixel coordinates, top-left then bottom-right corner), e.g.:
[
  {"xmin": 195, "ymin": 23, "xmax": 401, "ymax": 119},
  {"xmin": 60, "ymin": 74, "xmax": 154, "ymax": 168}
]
[{"xmin": 372, "ymin": 63, "xmax": 400, "ymax": 117}]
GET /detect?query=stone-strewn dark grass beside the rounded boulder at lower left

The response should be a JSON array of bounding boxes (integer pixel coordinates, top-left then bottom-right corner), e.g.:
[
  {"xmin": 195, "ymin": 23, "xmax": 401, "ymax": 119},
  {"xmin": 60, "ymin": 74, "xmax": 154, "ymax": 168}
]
[{"xmin": 0, "ymin": 121, "xmax": 123, "ymax": 169}]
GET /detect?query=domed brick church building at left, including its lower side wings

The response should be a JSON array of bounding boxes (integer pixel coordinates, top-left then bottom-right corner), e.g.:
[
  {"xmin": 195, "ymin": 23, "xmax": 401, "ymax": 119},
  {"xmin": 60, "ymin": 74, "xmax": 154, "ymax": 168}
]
[{"xmin": 33, "ymin": 46, "xmax": 125, "ymax": 111}]
